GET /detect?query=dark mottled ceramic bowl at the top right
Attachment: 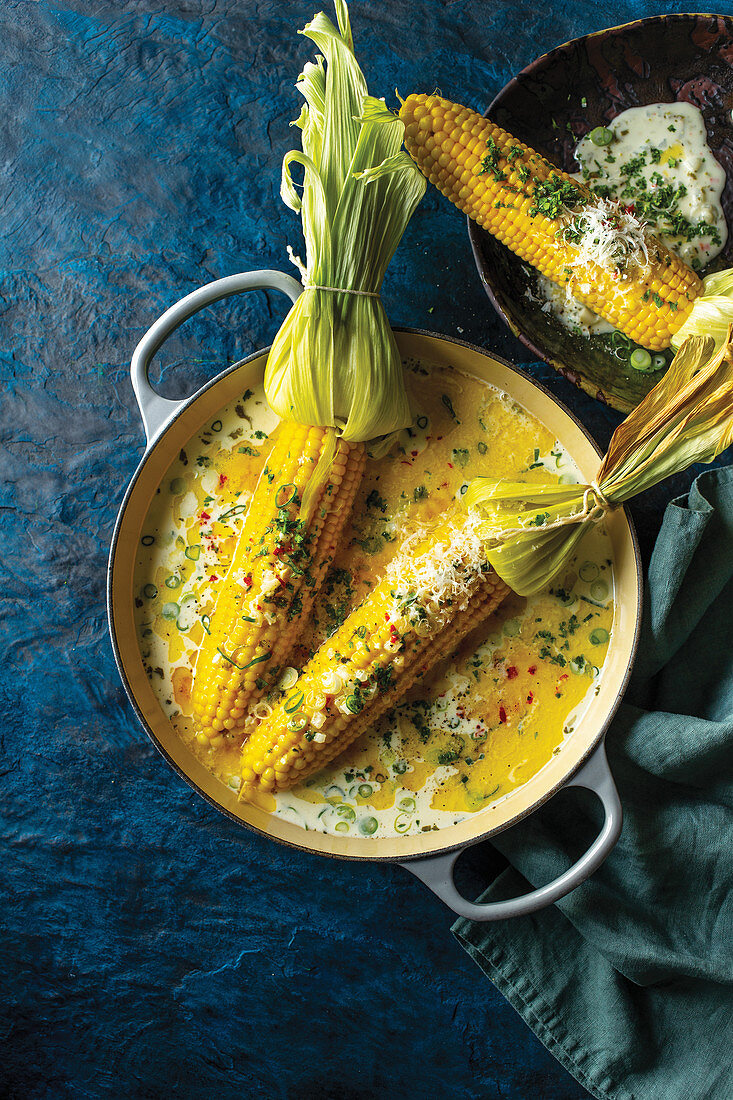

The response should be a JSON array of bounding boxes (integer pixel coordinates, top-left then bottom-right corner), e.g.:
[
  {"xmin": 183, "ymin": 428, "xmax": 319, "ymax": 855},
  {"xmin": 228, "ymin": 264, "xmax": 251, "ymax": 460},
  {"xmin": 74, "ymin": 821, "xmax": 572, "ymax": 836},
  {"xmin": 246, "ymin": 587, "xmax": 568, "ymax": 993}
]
[{"xmin": 469, "ymin": 15, "xmax": 733, "ymax": 411}]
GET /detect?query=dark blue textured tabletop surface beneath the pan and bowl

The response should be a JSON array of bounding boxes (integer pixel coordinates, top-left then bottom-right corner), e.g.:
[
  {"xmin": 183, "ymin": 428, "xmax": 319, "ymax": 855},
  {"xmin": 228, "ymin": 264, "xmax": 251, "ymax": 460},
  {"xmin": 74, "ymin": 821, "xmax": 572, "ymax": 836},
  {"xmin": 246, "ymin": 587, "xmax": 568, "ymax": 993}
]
[{"xmin": 0, "ymin": 0, "xmax": 717, "ymax": 1100}]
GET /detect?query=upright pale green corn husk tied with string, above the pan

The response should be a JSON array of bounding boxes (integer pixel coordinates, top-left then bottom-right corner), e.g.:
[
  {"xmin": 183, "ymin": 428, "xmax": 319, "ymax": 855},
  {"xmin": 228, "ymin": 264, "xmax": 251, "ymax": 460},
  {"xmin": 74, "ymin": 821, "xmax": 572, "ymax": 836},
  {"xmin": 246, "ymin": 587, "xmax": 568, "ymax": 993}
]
[{"xmin": 260, "ymin": 0, "xmax": 427, "ymax": 442}]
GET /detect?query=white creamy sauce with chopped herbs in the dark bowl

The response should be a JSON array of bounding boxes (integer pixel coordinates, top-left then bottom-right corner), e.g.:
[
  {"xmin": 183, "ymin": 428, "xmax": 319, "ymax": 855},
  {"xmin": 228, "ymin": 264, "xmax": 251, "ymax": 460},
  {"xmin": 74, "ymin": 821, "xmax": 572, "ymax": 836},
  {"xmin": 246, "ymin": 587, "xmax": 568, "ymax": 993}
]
[{"xmin": 538, "ymin": 103, "xmax": 727, "ymax": 336}]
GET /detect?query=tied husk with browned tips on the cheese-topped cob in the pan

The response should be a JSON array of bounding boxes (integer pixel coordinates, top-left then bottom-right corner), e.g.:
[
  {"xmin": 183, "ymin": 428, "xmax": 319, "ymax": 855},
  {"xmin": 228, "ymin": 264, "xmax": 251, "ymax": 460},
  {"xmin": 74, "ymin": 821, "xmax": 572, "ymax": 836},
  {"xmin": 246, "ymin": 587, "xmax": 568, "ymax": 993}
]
[{"xmin": 462, "ymin": 327, "xmax": 733, "ymax": 595}]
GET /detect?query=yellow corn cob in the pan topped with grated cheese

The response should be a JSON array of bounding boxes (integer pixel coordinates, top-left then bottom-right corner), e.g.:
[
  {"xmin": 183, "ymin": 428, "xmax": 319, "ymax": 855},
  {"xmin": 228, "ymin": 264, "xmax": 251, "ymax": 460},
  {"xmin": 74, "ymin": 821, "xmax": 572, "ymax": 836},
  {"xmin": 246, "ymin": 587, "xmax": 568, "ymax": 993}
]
[{"xmin": 240, "ymin": 513, "xmax": 510, "ymax": 801}]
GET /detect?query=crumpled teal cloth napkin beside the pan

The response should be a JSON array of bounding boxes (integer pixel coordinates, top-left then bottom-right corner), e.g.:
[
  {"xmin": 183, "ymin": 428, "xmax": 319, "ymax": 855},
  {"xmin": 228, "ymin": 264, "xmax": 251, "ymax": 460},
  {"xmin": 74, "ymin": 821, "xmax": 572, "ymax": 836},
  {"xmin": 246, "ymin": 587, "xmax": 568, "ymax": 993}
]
[{"xmin": 453, "ymin": 466, "xmax": 733, "ymax": 1100}]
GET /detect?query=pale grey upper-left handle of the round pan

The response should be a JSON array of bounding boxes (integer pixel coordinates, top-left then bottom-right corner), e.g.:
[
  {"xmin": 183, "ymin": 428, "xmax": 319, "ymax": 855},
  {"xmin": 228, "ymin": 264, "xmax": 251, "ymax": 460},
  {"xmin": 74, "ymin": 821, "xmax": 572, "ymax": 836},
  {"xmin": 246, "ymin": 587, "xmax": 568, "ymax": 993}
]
[{"xmin": 130, "ymin": 271, "xmax": 303, "ymax": 446}]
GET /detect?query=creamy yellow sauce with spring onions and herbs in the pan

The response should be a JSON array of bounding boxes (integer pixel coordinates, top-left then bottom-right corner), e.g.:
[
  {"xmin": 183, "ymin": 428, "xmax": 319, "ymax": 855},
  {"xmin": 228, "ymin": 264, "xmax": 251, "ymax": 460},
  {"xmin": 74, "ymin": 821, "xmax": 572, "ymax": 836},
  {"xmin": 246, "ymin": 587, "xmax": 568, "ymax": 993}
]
[{"xmin": 134, "ymin": 364, "xmax": 613, "ymax": 836}]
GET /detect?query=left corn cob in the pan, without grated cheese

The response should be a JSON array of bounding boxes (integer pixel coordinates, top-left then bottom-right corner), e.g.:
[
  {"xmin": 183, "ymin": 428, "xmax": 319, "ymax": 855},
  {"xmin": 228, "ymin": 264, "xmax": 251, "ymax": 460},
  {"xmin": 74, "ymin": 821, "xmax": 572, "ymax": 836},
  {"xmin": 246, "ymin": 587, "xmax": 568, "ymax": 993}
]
[{"xmin": 192, "ymin": 422, "xmax": 367, "ymax": 746}]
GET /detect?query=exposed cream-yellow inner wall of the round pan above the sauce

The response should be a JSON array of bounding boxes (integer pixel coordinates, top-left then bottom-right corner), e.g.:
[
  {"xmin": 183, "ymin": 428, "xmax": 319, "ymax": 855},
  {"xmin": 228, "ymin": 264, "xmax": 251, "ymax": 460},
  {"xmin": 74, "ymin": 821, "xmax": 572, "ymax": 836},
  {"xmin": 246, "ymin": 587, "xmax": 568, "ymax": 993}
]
[{"xmin": 109, "ymin": 330, "xmax": 642, "ymax": 859}]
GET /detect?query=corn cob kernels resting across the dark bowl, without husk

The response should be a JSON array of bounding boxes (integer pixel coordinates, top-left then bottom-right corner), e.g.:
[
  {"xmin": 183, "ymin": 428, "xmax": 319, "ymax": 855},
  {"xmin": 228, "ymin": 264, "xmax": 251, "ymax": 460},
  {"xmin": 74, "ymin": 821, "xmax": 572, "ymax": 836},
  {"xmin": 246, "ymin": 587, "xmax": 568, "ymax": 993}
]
[{"xmin": 400, "ymin": 95, "xmax": 703, "ymax": 351}]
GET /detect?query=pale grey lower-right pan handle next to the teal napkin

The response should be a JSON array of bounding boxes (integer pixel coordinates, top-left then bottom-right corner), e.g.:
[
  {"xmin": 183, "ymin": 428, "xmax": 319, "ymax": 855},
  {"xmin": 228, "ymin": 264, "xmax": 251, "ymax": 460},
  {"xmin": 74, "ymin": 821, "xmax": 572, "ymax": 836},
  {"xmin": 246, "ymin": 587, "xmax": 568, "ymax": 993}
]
[{"xmin": 402, "ymin": 741, "xmax": 623, "ymax": 921}]
